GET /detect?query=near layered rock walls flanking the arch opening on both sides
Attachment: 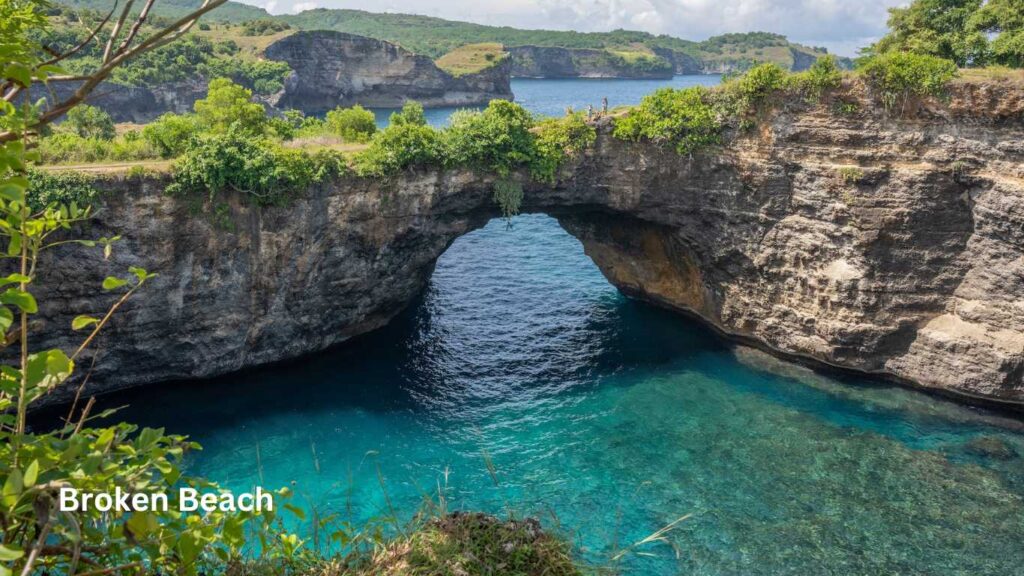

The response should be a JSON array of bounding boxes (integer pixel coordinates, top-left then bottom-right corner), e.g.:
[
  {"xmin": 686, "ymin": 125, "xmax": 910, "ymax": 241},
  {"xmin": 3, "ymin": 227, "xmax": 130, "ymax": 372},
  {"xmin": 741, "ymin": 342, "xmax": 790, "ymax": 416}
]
[{"xmin": 28, "ymin": 79, "xmax": 1024, "ymax": 402}]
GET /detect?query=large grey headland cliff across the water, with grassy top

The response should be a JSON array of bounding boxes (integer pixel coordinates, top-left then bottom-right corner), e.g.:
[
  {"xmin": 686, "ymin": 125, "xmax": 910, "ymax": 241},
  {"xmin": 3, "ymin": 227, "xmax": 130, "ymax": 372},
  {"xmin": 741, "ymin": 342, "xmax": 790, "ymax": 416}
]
[{"xmin": 265, "ymin": 31, "xmax": 512, "ymax": 113}]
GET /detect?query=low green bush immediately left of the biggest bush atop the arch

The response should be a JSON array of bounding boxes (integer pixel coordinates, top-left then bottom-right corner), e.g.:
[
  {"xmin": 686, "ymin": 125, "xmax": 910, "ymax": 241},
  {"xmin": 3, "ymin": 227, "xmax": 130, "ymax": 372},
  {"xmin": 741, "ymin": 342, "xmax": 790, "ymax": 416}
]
[{"xmin": 355, "ymin": 124, "xmax": 442, "ymax": 176}]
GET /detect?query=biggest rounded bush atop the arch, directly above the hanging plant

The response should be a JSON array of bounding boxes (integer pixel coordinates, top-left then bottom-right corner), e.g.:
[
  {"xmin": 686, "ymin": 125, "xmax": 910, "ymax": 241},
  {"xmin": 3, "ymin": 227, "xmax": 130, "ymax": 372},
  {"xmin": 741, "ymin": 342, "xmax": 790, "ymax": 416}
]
[{"xmin": 442, "ymin": 100, "xmax": 535, "ymax": 176}]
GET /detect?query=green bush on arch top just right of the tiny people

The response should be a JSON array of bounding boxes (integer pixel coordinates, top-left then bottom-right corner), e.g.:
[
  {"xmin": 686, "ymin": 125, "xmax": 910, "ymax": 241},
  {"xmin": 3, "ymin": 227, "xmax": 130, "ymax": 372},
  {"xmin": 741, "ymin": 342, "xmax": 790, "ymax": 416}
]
[{"xmin": 613, "ymin": 86, "xmax": 722, "ymax": 155}]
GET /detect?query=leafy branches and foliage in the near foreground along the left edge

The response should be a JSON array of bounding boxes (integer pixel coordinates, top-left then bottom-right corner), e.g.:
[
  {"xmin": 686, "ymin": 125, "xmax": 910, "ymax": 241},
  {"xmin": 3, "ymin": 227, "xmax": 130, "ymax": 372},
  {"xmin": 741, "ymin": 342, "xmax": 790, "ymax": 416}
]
[{"xmin": 0, "ymin": 0, "xmax": 301, "ymax": 576}]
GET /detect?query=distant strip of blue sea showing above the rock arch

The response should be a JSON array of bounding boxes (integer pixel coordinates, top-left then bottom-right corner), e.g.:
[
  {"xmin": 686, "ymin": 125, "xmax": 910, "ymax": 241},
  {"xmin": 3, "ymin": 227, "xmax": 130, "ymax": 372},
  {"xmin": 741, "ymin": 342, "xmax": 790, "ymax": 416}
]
[{"xmin": 374, "ymin": 75, "xmax": 722, "ymax": 128}]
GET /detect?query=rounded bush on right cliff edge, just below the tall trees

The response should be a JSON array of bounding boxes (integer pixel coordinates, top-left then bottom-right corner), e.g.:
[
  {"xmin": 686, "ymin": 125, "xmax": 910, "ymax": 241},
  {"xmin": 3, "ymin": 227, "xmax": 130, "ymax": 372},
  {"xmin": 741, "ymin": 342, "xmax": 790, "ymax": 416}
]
[{"xmin": 860, "ymin": 52, "xmax": 957, "ymax": 110}]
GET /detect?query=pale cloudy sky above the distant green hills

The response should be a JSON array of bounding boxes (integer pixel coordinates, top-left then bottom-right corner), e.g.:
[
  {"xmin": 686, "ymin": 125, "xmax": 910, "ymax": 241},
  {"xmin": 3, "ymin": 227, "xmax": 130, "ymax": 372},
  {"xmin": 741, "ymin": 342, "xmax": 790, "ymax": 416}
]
[{"xmin": 241, "ymin": 0, "xmax": 906, "ymax": 56}]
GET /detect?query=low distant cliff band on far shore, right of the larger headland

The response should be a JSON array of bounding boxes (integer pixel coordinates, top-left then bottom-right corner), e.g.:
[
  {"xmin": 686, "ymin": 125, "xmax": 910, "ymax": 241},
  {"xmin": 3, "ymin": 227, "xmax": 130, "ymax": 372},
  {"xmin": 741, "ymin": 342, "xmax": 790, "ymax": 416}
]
[{"xmin": 508, "ymin": 46, "xmax": 675, "ymax": 79}]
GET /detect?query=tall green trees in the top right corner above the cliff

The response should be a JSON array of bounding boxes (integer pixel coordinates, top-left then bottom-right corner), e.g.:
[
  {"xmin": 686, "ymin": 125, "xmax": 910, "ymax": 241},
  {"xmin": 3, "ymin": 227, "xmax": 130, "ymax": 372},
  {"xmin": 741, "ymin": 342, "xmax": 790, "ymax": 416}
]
[{"xmin": 865, "ymin": 0, "xmax": 1024, "ymax": 68}]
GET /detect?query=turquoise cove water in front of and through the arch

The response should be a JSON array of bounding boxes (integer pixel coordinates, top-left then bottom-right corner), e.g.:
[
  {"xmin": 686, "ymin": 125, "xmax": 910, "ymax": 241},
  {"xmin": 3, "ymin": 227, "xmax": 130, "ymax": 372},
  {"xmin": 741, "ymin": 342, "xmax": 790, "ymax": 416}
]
[{"xmin": 103, "ymin": 215, "xmax": 1024, "ymax": 576}]
